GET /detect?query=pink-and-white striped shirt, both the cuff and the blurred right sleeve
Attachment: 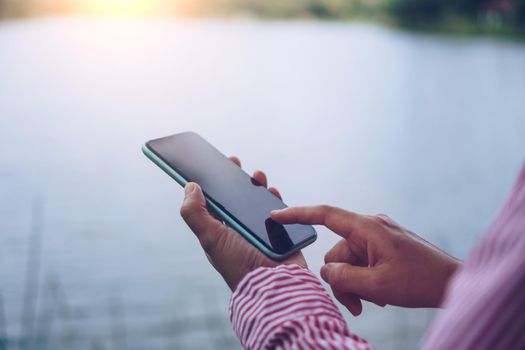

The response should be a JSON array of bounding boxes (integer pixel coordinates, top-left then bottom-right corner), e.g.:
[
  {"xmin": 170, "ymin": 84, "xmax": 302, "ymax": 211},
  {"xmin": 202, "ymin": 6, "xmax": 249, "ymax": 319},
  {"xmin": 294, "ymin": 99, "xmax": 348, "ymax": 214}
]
[{"xmin": 230, "ymin": 167, "xmax": 525, "ymax": 349}]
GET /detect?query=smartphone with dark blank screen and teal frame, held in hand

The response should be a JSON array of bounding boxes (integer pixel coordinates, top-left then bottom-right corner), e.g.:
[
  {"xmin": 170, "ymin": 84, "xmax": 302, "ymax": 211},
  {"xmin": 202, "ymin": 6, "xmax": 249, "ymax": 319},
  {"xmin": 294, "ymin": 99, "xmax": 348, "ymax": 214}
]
[{"xmin": 142, "ymin": 132, "xmax": 317, "ymax": 260}]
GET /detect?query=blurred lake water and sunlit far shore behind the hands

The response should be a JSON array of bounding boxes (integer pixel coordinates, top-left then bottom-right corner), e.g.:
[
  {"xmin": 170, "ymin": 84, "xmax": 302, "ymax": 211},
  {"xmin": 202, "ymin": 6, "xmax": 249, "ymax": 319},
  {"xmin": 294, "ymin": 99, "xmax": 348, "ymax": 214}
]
[{"xmin": 0, "ymin": 0, "xmax": 525, "ymax": 350}]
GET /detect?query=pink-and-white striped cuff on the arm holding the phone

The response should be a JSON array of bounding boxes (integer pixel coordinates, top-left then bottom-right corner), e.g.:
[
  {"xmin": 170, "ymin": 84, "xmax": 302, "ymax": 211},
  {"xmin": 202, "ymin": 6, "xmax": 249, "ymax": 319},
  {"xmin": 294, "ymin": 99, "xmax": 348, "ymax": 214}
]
[{"xmin": 230, "ymin": 265, "xmax": 373, "ymax": 349}]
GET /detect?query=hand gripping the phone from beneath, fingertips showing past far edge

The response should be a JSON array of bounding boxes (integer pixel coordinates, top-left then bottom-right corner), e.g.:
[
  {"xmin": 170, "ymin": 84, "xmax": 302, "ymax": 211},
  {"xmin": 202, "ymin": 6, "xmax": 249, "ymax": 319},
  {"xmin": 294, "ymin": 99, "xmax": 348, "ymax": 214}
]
[{"xmin": 180, "ymin": 157, "xmax": 307, "ymax": 290}]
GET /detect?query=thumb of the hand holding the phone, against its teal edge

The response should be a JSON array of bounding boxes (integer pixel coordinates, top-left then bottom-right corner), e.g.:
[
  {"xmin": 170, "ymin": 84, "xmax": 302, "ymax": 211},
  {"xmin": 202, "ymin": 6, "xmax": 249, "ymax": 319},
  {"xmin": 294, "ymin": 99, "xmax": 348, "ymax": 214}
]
[{"xmin": 180, "ymin": 182, "xmax": 225, "ymax": 251}]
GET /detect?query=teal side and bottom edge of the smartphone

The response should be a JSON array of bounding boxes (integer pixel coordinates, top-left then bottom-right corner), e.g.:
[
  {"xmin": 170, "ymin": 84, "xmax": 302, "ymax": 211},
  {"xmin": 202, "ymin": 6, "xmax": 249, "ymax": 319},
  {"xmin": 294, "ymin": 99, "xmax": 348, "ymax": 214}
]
[{"xmin": 142, "ymin": 143, "xmax": 317, "ymax": 261}]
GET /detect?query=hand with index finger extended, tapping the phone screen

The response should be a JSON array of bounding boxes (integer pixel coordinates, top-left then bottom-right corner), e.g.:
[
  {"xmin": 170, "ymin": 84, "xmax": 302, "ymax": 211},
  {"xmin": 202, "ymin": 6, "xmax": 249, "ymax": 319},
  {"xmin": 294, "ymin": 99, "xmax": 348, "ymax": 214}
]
[{"xmin": 271, "ymin": 205, "xmax": 461, "ymax": 315}]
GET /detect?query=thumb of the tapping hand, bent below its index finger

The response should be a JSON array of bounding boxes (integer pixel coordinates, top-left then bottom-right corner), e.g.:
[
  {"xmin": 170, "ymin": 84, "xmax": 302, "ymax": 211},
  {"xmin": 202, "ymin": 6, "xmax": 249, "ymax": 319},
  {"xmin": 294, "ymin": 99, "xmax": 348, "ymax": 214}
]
[{"xmin": 321, "ymin": 263, "xmax": 377, "ymax": 300}]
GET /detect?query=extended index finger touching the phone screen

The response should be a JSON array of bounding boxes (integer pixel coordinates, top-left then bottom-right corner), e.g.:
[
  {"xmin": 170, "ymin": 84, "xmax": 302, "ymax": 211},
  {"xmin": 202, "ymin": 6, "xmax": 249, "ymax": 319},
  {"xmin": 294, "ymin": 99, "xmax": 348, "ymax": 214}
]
[{"xmin": 271, "ymin": 205, "xmax": 365, "ymax": 238}]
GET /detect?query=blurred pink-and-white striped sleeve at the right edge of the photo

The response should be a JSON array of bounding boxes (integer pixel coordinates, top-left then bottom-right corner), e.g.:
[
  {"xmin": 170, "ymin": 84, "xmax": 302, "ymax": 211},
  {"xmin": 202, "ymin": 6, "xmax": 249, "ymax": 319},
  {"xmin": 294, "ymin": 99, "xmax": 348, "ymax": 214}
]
[{"xmin": 423, "ymin": 167, "xmax": 525, "ymax": 350}]
